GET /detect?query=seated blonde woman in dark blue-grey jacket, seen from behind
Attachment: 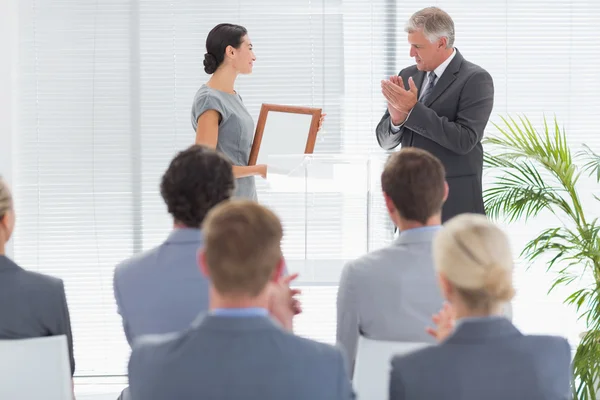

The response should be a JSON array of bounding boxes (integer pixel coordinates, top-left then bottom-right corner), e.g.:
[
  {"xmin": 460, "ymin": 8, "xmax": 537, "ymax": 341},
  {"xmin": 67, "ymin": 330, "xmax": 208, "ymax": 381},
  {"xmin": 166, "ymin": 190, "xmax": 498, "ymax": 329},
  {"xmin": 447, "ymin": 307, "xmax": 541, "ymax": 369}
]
[{"xmin": 390, "ymin": 214, "xmax": 572, "ymax": 400}]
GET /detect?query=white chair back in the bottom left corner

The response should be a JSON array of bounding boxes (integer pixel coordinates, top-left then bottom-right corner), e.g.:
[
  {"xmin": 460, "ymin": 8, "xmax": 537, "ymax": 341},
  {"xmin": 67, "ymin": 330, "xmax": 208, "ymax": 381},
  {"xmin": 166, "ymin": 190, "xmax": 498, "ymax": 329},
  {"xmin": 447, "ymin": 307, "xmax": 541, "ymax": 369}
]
[{"xmin": 0, "ymin": 335, "xmax": 73, "ymax": 400}]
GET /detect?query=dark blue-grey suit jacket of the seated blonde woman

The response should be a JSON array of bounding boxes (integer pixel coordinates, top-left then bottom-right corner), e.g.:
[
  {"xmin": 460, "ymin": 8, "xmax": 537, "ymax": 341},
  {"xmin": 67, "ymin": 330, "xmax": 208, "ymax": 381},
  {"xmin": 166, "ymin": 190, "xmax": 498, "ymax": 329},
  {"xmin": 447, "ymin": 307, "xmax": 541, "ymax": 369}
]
[{"xmin": 390, "ymin": 318, "xmax": 572, "ymax": 400}]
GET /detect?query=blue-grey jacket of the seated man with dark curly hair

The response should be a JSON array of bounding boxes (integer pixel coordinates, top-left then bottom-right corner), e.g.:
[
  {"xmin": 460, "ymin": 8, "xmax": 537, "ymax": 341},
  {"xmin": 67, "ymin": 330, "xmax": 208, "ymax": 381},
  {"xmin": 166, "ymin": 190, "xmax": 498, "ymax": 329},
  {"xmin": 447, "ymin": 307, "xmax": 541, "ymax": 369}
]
[{"xmin": 113, "ymin": 228, "xmax": 209, "ymax": 345}]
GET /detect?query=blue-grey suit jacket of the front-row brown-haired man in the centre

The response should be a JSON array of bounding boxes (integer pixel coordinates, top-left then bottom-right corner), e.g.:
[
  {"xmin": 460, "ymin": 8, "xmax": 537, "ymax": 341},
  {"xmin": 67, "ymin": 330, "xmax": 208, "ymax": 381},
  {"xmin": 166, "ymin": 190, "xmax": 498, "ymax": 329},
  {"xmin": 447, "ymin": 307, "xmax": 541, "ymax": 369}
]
[{"xmin": 129, "ymin": 315, "xmax": 354, "ymax": 400}]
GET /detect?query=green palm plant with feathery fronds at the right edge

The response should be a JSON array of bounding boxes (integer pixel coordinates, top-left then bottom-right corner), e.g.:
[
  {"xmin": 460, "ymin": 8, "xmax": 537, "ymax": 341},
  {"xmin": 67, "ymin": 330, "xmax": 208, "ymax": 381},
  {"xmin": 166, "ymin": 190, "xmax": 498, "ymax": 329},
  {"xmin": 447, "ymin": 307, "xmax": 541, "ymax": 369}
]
[{"xmin": 484, "ymin": 117, "xmax": 600, "ymax": 400}]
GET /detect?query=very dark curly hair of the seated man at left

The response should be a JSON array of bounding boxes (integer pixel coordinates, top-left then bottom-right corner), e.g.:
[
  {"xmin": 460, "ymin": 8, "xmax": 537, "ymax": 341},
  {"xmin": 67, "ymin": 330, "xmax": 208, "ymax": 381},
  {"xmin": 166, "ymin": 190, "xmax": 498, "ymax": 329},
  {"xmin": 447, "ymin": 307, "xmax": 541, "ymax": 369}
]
[{"xmin": 160, "ymin": 145, "xmax": 235, "ymax": 228}]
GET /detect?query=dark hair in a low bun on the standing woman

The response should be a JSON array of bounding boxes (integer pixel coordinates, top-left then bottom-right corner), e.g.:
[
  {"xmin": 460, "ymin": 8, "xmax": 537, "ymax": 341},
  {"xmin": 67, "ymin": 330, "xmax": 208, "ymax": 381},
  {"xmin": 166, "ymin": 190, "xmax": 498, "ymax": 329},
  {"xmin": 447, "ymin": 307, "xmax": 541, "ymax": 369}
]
[{"xmin": 204, "ymin": 24, "xmax": 248, "ymax": 74}]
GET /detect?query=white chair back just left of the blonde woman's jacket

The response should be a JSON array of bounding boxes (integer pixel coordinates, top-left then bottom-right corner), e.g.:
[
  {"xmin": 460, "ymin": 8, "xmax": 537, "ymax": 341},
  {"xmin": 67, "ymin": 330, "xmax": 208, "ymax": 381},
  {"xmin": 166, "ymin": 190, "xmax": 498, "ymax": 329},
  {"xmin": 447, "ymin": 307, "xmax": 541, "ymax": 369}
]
[{"xmin": 352, "ymin": 336, "xmax": 429, "ymax": 400}]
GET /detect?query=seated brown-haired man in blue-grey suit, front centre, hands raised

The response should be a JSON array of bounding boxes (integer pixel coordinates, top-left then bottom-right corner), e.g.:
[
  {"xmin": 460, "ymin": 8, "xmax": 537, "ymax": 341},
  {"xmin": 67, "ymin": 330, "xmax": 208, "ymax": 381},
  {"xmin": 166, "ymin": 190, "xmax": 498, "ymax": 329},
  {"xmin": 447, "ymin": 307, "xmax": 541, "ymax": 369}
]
[{"xmin": 129, "ymin": 200, "xmax": 354, "ymax": 400}]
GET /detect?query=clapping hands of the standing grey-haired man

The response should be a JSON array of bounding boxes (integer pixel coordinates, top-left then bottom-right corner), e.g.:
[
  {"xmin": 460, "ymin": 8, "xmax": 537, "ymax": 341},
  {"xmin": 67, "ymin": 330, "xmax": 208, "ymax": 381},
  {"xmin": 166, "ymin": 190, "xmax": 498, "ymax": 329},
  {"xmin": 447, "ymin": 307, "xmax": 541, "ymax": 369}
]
[{"xmin": 381, "ymin": 75, "xmax": 419, "ymax": 125}]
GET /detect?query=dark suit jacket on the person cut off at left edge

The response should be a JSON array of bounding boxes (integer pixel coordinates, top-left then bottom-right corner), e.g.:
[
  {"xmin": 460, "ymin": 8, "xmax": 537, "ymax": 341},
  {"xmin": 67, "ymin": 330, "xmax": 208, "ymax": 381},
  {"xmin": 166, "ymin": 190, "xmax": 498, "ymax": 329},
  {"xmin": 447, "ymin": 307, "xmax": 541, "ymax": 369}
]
[{"xmin": 0, "ymin": 255, "xmax": 75, "ymax": 374}]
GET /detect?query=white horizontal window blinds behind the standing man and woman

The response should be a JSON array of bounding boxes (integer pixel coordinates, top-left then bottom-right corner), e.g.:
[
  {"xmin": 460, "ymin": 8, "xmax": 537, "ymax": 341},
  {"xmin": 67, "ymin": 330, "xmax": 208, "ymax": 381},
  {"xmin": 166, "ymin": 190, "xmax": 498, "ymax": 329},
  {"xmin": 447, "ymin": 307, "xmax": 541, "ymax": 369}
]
[{"xmin": 13, "ymin": 0, "xmax": 600, "ymax": 375}]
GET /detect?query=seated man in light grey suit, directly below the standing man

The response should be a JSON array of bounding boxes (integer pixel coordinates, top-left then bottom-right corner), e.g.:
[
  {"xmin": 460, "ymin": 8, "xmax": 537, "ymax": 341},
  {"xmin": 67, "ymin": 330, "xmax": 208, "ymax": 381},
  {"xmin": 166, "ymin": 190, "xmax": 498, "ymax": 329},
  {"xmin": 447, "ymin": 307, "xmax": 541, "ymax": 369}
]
[{"xmin": 337, "ymin": 148, "xmax": 448, "ymax": 376}]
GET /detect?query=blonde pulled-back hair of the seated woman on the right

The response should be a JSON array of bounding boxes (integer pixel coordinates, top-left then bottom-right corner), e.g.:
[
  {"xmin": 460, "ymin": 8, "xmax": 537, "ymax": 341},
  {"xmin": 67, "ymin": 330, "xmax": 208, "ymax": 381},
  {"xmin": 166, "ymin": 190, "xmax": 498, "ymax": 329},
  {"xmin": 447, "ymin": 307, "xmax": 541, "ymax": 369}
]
[{"xmin": 433, "ymin": 214, "xmax": 515, "ymax": 309}]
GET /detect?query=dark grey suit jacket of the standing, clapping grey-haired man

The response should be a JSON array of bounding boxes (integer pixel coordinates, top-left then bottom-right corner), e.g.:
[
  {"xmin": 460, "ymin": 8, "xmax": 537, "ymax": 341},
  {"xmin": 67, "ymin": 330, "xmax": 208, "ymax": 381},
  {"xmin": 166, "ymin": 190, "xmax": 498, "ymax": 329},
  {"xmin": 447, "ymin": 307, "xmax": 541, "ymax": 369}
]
[{"xmin": 376, "ymin": 49, "xmax": 494, "ymax": 221}]
